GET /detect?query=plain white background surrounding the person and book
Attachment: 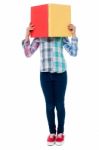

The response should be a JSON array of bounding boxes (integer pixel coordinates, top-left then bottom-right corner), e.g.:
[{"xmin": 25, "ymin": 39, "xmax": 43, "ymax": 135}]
[{"xmin": 0, "ymin": 0, "xmax": 99, "ymax": 150}]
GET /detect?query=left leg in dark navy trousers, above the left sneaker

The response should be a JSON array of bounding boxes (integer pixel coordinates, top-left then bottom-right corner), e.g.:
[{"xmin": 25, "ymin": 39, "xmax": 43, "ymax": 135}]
[{"xmin": 40, "ymin": 72, "xmax": 56, "ymax": 133}]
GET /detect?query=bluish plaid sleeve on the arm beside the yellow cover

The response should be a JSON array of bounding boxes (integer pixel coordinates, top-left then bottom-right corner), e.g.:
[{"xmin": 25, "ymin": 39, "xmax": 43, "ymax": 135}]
[{"xmin": 63, "ymin": 37, "xmax": 78, "ymax": 56}]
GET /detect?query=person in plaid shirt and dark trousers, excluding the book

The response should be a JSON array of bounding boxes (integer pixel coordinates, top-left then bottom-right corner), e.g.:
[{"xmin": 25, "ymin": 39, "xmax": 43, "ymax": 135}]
[{"xmin": 22, "ymin": 24, "xmax": 78, "ymax": 145}]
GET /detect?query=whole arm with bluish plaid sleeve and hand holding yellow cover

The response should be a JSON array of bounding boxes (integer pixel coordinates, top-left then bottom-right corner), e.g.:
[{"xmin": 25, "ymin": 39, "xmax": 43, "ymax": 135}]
[{"xmin": 63, "ymin": 24, "xmax": 78, "ymax": 56}]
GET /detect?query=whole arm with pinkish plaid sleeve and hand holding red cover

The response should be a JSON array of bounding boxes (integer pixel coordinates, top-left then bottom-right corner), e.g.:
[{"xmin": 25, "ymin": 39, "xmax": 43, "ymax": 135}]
[{"xmin": 22, "ymin": 23, "xmax": 40, "ymax": 57}]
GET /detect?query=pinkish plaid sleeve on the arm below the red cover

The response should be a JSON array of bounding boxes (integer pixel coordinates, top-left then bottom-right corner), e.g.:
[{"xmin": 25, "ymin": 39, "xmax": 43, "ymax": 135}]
[{"xmin": 22, "ymin": 38, "xmax": 40, "ymax": 57}]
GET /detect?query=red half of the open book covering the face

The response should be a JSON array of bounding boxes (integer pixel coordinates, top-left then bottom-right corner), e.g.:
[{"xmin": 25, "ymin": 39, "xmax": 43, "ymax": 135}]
[{"xmin": 31, "ymin": 4, "xmax": 48, "ymax": 37}]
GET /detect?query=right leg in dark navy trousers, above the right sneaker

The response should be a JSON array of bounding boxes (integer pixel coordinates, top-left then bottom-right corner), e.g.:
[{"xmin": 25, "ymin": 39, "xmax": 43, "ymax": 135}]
[{"xmin": 54, "ymin": 72, "xmax": 67, "ymax": 134}]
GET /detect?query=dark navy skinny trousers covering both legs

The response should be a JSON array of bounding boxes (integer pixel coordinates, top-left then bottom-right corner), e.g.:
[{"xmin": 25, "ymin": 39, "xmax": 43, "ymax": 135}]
[{"xmin": 40, "ymin": 71, "xmax": 67, "ymax": 134}]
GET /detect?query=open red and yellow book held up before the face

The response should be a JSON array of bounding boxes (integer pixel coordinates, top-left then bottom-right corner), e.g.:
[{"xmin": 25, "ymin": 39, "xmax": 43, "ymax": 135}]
[{"xmin": 31, "ymin": 4, "xmax": 71, "ymax": 37}]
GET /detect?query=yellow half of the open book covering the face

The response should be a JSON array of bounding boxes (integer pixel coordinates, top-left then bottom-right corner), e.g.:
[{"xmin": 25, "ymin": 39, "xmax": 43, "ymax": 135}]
[{"xmin": 48, "ymin": 4, "xmax": 71, "ymax": 37}]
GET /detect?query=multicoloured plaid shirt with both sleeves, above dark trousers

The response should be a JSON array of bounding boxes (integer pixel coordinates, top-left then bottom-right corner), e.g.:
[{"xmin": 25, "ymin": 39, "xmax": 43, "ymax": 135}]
[{"xmin": 22, "ymin": 37, "xmax": 78, "ymax": 73}]
